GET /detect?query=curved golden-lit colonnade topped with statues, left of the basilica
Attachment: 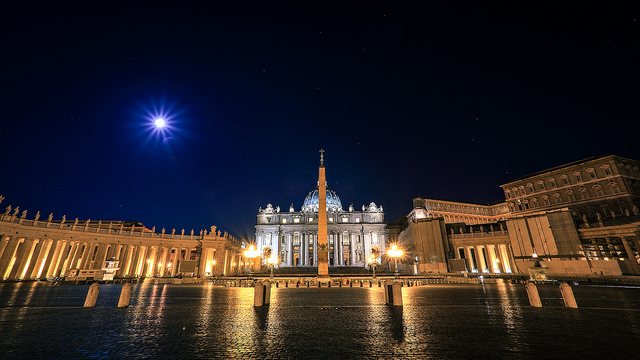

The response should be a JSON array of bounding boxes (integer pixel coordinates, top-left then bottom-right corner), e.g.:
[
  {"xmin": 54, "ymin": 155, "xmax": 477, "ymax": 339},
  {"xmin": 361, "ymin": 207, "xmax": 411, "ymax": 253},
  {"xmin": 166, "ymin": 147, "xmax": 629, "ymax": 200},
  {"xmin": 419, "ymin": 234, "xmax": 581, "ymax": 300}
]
[{"xmin": 0, "ymin": 211, "xmax": 242, "ymax": 281}]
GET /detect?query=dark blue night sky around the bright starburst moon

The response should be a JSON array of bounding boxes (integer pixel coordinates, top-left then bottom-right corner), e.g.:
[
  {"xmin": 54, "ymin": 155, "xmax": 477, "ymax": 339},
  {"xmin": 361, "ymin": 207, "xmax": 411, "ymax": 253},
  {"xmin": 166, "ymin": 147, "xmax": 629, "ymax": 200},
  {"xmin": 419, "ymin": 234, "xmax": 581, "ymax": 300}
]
[{"xmin": 0, "ymin": 1, "xmax": 640, "ymax": 240}]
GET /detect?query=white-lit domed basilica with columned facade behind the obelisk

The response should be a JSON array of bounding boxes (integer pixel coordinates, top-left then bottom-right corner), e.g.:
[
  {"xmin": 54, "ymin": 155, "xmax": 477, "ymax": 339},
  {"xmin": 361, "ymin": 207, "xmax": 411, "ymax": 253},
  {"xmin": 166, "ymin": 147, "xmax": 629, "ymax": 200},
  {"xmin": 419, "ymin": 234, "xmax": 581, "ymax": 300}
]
[{"xmin": 256, "ymin": 187, "xmax": 387, "ymax": 267}]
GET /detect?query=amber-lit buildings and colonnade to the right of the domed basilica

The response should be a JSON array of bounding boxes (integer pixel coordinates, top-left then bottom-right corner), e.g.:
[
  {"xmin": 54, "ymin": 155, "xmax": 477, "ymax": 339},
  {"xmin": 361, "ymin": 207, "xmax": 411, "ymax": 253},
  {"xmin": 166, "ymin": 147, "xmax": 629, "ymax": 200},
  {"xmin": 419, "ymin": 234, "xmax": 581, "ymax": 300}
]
[{"xmin": 398, "ymin": 155, "xmax": 640, "ymax": 275}]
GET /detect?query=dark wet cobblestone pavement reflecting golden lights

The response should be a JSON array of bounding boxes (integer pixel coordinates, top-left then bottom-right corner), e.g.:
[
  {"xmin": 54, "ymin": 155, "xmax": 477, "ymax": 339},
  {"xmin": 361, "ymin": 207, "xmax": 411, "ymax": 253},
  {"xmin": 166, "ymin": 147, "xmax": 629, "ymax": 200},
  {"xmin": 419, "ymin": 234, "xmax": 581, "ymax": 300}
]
[{"xmin": 0, "ymin": 283, "xmax": 640, "ymax": 359}]
